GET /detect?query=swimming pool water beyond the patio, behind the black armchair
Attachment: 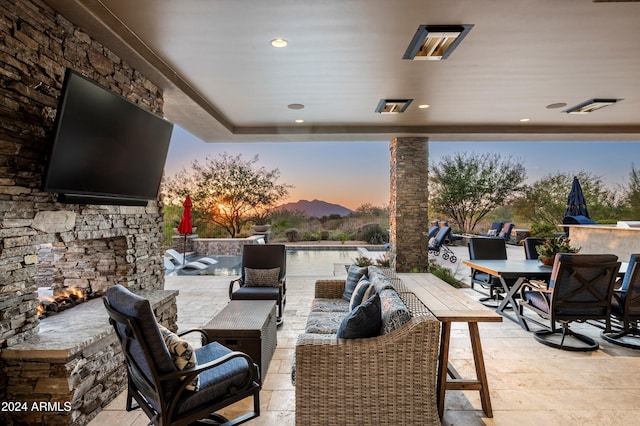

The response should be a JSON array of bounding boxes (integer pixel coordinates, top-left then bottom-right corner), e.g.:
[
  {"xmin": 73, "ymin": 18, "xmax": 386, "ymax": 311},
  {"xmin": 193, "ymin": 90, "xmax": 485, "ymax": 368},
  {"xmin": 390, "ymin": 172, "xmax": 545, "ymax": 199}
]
[{"xmin": 169, "ymin": 247, "xmax": 370, "ymax": 277}]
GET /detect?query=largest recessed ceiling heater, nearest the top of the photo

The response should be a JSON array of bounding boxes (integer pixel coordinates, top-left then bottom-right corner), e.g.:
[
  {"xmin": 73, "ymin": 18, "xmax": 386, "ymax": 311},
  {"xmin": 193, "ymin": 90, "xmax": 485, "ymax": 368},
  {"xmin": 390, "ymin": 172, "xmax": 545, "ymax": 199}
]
[{"xmin": 402, "ymin": 25, "xmax": 473, "ymax": 61}]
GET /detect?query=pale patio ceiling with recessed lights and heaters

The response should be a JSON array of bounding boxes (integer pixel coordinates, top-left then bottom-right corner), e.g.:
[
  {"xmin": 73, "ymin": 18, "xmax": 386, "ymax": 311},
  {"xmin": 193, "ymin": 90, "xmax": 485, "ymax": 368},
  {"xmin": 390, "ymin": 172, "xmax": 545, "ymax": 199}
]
[{"xmin": 46, "ymin": 0, "xmax": 640, "ymax": 142}]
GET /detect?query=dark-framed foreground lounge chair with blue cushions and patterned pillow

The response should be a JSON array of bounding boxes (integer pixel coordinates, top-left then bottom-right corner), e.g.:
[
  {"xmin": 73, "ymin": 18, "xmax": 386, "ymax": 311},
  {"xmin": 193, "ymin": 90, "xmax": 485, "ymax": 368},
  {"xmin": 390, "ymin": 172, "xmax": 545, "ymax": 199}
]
[{"xmin": 103, "ymin": 285, "xmax": 260, "ymax": 426}]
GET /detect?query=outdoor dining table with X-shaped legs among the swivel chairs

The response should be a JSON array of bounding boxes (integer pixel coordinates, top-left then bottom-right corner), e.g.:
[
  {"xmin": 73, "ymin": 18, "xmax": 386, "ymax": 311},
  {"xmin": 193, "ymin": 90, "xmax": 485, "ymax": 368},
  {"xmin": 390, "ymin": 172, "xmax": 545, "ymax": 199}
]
[{"xmin": 462, "ymin": 259, "xmax": 628, "ymax": 331}]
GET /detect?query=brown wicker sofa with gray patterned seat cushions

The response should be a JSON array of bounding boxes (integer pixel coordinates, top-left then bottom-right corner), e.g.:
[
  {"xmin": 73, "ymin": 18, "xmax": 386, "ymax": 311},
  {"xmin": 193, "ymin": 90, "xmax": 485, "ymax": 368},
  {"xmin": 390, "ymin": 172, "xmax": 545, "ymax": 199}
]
[{"xmin": 292, "ymin": 267, "xmax": 440, "ymax": 425}]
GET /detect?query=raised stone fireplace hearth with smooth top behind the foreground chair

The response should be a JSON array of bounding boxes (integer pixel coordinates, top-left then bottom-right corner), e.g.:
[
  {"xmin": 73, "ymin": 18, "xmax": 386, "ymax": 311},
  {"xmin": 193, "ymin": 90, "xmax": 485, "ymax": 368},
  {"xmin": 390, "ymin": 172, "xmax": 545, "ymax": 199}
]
[{"xmin": 0, "ymin": 290, "xmax": 178, "ymax": 426}]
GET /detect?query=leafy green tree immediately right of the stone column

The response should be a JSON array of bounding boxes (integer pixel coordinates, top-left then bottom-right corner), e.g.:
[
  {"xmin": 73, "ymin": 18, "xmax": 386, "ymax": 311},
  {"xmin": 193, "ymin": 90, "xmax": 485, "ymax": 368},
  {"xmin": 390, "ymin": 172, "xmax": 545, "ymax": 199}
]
[{"xmin": 429, "ymin": 153, "xmax": 526, "ymax": 232}]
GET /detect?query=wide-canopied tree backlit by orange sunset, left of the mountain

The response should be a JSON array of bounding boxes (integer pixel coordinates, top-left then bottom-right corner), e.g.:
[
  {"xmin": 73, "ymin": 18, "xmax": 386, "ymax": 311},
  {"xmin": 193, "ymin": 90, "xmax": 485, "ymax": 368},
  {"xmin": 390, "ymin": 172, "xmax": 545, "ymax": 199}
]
[{"xmin": 162, "ymin": 153, "xmax": 291, "ymax": 238}]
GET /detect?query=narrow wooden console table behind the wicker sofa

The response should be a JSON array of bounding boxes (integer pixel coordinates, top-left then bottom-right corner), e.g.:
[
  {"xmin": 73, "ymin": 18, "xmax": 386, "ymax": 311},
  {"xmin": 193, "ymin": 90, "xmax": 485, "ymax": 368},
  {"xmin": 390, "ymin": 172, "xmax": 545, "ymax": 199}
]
[{"xmin": 397, "ymin": 274, "xmax": 502, "ymax": 417}]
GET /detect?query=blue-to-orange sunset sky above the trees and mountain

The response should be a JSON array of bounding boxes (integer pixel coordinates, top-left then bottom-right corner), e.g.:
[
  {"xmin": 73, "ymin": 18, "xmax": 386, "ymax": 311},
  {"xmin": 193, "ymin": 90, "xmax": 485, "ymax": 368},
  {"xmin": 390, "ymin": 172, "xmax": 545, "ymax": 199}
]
[{"xmin": 165, "ymin": 126, "xmax": 640, "ymax": 209}]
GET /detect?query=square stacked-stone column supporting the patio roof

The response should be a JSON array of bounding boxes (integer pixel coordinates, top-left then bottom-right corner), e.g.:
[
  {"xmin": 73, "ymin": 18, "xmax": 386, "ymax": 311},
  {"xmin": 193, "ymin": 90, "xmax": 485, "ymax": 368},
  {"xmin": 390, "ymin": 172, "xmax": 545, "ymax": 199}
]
[{"xmin": 389, "ymin": 137, "xmax": 429, "ymax": 272}]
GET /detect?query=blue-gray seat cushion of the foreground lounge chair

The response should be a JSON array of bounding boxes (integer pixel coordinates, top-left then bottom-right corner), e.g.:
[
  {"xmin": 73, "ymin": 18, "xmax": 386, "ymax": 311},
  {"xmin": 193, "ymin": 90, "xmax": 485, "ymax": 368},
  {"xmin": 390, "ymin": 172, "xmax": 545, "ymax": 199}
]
[{"xmin": 177, "ymin": 342, "xmax": 255, "ymax": 413}]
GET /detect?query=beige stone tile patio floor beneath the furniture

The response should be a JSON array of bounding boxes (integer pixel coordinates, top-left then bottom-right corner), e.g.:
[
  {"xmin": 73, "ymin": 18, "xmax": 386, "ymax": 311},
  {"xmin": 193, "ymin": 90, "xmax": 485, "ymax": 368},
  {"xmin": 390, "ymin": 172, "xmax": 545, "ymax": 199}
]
[{"xmin": 90, "ymin": 246, "xmax": 640, "ymax": 426}]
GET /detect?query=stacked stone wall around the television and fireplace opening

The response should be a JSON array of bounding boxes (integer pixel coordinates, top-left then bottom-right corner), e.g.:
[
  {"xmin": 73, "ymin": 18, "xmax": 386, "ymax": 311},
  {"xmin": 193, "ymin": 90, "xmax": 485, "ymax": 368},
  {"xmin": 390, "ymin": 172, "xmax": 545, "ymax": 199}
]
[{"xmin": 0, "ymin": 0, "xmax": 164, "ymax": 412}]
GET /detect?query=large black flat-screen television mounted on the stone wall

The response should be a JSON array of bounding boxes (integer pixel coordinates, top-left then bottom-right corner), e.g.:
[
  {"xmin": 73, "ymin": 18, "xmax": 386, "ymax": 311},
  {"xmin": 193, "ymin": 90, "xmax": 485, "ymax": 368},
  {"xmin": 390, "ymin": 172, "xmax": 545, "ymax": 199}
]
[{"xmin": 43, "ymin": 70, "xmax": 173, "ymax": 205}]
